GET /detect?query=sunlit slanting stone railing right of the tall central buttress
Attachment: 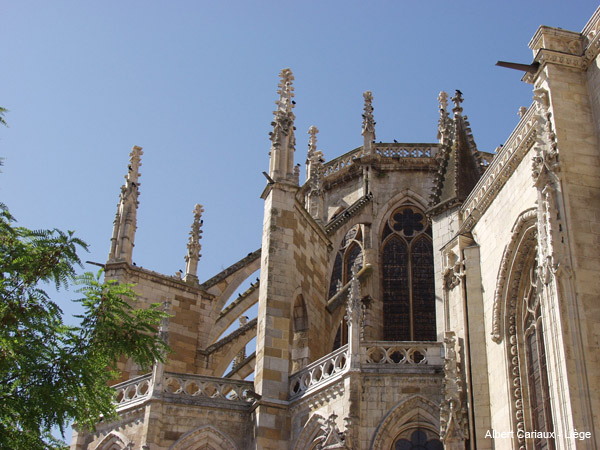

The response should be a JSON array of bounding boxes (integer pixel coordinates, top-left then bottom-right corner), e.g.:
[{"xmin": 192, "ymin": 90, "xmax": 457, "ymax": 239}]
[{"xmin": 290, "ymin": 344, "xmax": 350, "ymax": 400}]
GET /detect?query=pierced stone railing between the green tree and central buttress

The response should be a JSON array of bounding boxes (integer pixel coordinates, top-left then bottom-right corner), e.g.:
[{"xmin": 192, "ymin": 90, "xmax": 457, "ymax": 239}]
[{"xmin": 163, "ymin": 372, "xmax": 255, "ymax": 403}]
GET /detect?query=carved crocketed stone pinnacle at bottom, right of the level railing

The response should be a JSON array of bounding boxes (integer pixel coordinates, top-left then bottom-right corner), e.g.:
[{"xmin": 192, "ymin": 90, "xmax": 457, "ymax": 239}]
[{"xmin": 440, "ymin": 331, "xmax": 469, "ymax": 448}]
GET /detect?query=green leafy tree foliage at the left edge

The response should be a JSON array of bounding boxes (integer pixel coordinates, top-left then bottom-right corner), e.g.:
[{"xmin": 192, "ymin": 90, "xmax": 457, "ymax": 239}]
[{"xmin": 0, "ymin": 203, "xmax": 168, "ymax": 450}]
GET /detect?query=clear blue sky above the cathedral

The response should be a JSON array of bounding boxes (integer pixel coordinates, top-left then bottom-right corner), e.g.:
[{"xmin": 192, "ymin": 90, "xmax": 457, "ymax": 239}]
[{"xmin": 0, "ymin": 0, "xmax": 597, "ymax": 442}]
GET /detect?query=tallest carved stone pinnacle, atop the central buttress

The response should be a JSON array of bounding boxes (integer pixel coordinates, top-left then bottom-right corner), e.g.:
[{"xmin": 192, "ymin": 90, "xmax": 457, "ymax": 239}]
[{"xmin": 269, "ymin": 69, "xmax": 296, "ymax": 182}]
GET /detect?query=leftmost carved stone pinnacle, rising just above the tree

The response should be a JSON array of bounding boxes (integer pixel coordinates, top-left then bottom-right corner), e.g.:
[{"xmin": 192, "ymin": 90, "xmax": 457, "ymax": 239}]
[{"xmin": 108, "ymin": 145, "xmax": 144, "ymax": 264}]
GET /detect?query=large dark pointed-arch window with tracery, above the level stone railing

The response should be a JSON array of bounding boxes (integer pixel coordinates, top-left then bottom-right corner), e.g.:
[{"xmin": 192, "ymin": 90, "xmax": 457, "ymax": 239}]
[{"xmin": 380, "ymin": 205, "xmax": 437, "ymax": 341}]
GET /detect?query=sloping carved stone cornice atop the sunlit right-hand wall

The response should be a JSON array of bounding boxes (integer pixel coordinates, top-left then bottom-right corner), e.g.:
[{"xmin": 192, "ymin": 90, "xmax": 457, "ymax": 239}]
[{"xmin": 461, "ymin": 106, "xmax": 537, "ymax": 233}]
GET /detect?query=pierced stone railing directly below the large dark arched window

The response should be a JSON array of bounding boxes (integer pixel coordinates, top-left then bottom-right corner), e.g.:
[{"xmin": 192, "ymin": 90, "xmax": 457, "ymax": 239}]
[{"xmin": 360, "ymin": 341, "xmax": 444, "ymax": 367}]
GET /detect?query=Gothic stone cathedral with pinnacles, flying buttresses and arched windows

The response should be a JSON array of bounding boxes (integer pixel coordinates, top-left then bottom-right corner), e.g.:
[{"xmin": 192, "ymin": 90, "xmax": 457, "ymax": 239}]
[{"xmin": 71, "ymin": 9, "xmax": 600, "ymax": 450}]
